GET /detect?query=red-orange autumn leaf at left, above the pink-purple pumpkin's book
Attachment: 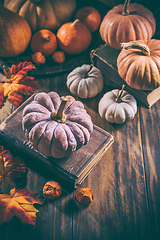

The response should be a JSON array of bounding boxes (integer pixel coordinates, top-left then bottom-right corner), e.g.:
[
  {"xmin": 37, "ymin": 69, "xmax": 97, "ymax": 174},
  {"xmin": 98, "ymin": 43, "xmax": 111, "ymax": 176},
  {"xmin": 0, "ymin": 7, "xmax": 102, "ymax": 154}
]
[{"xmin": 1, "ymin": 61, "xmax": 39, "ymax": 107}]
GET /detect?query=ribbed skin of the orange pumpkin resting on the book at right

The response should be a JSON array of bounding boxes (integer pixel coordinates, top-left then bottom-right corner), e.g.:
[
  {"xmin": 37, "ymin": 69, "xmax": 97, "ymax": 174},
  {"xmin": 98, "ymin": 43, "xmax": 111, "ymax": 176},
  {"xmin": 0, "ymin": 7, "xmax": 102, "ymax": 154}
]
[{"xmin": 117, "ymin": 39, "xmax": 160, "ymax": 90}]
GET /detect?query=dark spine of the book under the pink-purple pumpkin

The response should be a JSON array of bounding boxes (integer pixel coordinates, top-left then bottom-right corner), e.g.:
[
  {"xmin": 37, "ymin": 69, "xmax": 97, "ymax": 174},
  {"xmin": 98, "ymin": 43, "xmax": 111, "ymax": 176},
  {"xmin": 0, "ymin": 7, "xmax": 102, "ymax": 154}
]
[{"xmin": 0, "ymin": 130, "xmax": 77, "ymax": 188}]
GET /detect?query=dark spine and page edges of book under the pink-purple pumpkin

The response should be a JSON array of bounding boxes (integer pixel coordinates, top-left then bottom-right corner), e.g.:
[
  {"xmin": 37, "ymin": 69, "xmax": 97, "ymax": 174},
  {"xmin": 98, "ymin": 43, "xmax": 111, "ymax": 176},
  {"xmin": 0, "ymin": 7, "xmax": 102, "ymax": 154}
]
[{"xmin": 0, "ymin": 125, "xmax": 114, "ymax": 188}]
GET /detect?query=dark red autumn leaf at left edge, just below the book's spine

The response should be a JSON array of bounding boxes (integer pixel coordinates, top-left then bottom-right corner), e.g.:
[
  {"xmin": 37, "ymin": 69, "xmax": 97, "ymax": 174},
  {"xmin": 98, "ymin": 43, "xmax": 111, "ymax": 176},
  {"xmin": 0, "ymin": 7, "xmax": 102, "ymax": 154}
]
[{"xmin": 0, "ymin": 145, "xmax": 27, "ymax": 185}]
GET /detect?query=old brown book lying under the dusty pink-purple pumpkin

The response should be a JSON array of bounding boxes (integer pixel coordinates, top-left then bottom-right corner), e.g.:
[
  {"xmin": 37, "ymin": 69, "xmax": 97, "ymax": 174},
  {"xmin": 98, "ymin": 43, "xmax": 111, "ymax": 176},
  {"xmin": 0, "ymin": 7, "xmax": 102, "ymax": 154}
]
[{"xmin": 0, "ymin": 95, "xmax": 113, "ymax": 188}]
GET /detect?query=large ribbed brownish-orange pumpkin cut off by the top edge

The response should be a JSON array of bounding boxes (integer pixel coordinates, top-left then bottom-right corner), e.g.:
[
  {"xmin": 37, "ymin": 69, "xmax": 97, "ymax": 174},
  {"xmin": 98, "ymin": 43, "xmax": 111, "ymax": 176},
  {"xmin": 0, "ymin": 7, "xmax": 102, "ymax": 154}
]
[{"xmin": 4, "ymin": 0, "xmax": 76, "ymax": 32}]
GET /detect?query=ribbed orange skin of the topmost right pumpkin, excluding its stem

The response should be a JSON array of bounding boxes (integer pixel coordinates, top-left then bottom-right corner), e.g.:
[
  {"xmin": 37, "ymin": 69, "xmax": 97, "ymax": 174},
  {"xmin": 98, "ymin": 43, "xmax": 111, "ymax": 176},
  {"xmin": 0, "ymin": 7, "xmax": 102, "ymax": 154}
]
[{"xmin": 100, "ymin": 3, "xmax": 156, "ymax": 49}]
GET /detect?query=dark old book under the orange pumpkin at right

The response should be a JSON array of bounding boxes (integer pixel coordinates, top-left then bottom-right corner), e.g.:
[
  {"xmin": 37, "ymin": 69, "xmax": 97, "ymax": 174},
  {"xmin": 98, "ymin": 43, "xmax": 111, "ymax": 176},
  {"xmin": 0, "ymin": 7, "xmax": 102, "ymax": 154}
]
[{"xmin": 91, "ymin": 44, "xmax": 160, "ymax": 107}]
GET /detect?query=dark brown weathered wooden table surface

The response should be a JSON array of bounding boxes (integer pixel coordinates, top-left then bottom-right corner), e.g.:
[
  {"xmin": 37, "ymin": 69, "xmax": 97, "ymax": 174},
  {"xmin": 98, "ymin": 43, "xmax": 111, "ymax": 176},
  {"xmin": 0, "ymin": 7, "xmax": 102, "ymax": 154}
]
[{"xmin": 0, "ymin": 72, "xmax": 160, "ymax": 240}]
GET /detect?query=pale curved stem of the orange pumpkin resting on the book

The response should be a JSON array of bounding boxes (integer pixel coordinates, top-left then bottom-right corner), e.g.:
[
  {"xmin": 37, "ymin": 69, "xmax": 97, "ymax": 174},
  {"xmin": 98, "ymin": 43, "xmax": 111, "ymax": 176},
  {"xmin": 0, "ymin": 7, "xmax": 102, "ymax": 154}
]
[{"xmin": 120, "ymin": 41, "xmax": 150, "ymax": 56}]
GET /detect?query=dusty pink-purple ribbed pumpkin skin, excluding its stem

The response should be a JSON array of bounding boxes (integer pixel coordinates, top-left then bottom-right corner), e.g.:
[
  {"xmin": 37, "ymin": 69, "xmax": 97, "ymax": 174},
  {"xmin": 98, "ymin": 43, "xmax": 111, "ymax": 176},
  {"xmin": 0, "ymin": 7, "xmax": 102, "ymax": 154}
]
[{"xmin": 22, "ymin": 92, "xmax": 93, "ymax": 158}]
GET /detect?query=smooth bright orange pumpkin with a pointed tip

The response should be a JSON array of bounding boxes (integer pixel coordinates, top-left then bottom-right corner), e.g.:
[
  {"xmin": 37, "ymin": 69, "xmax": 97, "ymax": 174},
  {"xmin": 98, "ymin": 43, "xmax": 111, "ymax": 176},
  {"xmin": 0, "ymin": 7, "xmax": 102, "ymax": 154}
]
[{"xmin": 57, "ymin": 19, "xmax": 92, "ymax": 54}]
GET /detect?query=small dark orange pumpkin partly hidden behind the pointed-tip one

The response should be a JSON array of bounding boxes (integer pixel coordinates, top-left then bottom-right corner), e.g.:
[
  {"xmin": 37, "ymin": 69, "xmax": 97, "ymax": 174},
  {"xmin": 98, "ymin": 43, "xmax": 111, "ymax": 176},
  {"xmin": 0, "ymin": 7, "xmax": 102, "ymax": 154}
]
[{"xmin": 74, "ymin": 6, "xmax": 101, "ymax": 32}]
